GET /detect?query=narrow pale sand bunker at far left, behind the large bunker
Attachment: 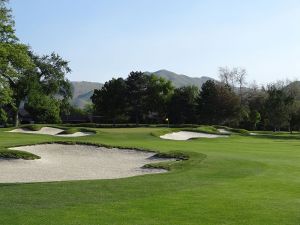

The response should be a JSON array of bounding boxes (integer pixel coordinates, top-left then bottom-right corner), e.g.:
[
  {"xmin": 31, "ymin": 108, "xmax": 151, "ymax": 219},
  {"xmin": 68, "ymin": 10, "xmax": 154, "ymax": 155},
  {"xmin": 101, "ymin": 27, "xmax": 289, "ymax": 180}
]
[{"xmin": 9, "ymin": 127, "xmax": 93, "ymax": 137}]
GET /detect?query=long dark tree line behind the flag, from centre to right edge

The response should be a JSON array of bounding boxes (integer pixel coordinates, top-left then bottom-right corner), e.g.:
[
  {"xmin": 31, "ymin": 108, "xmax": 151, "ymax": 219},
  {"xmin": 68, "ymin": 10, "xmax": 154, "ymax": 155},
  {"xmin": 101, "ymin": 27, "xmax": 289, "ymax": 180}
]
[{"xmin": 91, "ymin": 70, "xmax": 300, "ymax": 131}]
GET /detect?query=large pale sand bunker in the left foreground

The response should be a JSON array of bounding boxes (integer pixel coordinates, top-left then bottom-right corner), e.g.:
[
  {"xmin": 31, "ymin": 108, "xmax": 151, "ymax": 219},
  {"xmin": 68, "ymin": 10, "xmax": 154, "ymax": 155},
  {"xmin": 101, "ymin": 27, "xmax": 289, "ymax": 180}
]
[{"xmin": 0, "ymin": 144, "xmax": 170, "ymax": 183}]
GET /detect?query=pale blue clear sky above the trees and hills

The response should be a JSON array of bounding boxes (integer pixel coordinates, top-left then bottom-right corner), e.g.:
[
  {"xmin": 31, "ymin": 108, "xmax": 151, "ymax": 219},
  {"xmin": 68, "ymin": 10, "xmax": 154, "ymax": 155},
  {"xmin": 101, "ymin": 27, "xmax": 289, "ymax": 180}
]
[{"xmin": 10, "ymin": 0, "xmax": 300, "ymax": 83}]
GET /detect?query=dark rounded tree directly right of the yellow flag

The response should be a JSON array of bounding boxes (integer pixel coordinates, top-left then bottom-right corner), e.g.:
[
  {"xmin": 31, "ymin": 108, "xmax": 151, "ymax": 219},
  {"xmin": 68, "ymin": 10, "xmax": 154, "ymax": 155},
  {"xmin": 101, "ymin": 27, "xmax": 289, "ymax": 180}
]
[{"xmin": 168, "ymin": 86, "xmax": 199, "ymax": 124}]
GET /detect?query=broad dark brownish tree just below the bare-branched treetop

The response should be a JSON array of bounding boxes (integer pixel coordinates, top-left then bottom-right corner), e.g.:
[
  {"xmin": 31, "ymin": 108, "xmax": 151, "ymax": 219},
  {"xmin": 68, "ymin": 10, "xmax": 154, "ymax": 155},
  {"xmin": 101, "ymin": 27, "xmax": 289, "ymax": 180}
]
[{"xmin": 197, "ymin": 80, "xmax": 240, "ymax": 125}]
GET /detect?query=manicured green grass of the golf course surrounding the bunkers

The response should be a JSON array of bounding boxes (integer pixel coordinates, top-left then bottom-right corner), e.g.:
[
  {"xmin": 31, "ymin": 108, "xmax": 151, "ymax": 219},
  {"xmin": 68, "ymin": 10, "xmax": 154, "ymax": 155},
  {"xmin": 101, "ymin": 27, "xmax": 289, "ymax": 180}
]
[{"xmin": 0, "ymin": 128, "xmax": 300, "ymax": 225}]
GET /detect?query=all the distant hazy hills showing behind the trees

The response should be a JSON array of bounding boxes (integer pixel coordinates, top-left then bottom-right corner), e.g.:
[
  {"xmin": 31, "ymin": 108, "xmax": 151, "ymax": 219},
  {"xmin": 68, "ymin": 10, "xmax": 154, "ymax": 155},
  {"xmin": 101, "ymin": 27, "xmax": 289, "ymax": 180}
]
[{"xmin": 71, "ymin": 70, "xmax": 213, "ymax": 108}]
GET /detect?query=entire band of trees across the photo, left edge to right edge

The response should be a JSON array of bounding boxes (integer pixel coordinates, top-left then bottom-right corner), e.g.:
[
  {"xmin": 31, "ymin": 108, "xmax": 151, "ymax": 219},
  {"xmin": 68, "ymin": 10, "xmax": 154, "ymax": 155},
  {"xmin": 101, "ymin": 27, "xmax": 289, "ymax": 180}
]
[{"xmin": 0, "ymin": 0, "xmax": 300, "ymax": 131}]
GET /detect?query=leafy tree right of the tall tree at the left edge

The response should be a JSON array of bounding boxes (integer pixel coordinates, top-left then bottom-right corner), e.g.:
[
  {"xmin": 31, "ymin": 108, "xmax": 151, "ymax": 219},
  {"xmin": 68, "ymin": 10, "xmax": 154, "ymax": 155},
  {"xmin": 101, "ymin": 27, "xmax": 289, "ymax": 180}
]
[{"xmin": 14, "ymin": 52, "xmax": 72, "ymax": 123}]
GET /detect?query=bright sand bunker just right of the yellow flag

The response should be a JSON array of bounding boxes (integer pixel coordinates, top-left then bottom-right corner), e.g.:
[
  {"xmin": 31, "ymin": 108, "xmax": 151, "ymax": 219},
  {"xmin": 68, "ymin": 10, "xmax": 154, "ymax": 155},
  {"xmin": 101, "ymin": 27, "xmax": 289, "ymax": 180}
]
[{"xmin": 160, "ymin": 131, "xmax": 227, "ymax": 141}]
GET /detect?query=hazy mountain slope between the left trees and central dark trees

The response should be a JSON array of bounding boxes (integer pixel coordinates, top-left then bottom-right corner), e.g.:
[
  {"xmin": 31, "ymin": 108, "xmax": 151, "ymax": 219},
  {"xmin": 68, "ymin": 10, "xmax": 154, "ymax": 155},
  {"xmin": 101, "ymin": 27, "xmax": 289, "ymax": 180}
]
[{"xmin": 71, "ymin": 81, "xmax": 103, "ymax": 108}]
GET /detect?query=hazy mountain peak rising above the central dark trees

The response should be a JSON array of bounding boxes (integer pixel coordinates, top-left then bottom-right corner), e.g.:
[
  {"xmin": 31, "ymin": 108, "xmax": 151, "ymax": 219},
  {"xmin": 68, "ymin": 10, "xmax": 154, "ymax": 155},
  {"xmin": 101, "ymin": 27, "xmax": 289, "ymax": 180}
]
[{"xmin": 145, "ymin": 70, "xmax": 213, "ymax": 88}]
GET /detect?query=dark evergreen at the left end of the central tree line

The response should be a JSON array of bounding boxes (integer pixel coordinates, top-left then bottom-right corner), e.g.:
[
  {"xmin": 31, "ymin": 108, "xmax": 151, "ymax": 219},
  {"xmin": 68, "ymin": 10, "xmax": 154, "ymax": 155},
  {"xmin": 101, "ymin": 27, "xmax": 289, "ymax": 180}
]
[{"xmin": 91, "ymin": 78, "xmax": 127, "ymax": 124}]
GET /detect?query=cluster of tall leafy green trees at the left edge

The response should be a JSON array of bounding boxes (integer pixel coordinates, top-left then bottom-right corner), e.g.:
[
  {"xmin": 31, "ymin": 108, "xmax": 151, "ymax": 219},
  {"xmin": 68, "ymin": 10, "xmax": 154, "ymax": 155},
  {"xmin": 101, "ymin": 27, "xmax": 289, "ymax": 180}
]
[{"xmin": 0, "ymin": 0, "xmax": 72, "ymax": 126}]
